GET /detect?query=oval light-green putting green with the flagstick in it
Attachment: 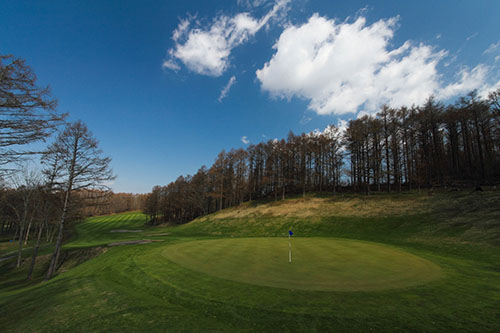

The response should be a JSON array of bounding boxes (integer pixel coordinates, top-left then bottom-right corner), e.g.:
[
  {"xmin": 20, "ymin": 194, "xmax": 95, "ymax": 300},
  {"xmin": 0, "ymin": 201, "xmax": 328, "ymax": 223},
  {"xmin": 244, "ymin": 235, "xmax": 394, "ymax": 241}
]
[{"xmin": 161, "ymin": 238, "xmax": 442, "ymax": 291}]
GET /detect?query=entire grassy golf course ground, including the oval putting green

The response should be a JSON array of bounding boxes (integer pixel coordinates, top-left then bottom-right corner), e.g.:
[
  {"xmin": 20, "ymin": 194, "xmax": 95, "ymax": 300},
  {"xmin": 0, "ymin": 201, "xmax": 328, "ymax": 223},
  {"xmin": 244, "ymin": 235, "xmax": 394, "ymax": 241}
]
[{"xmin": 0, "ymin": 191, "xmax": 500, "ymax": 332}]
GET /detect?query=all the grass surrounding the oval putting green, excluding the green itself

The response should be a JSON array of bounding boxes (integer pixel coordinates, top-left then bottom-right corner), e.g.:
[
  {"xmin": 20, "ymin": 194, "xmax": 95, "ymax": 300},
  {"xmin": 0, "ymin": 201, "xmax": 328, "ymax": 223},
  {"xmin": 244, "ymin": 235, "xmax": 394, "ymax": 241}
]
[{"xmin": 0, "ymin": 191, "xmax": 500, "ymax": 332}]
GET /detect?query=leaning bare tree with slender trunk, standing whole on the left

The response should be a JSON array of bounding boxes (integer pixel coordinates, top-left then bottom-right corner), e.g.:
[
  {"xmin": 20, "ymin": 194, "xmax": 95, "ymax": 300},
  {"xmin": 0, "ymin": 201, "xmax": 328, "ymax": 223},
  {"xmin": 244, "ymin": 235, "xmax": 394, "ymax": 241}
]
[{"xmin": 43, "ymin": 121, "xmax": 115, "ymax": 279}]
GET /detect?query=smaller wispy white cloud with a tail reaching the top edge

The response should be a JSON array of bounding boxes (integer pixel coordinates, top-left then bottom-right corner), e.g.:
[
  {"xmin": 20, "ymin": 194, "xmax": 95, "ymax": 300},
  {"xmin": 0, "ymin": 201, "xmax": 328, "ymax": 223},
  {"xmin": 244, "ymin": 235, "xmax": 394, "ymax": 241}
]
[{"xmin": 163, "ymin": 0, "xmax": 290, "ymax": 76}]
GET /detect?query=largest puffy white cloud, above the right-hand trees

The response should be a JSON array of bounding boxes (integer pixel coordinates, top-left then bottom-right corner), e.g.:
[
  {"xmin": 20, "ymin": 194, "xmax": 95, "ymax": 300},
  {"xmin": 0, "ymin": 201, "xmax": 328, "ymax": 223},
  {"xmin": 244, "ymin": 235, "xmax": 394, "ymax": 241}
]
[{"xmin": 256, "ymin": 14, "xmax": 487, "ymax": 114}]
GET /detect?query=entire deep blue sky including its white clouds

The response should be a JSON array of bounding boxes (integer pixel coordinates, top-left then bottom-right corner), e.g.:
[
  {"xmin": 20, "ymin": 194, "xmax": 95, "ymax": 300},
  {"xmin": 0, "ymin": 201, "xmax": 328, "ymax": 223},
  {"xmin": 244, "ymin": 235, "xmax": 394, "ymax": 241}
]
[{"xmin": 0, "ymin": 0, "xmax": 500, "ymax": 193}]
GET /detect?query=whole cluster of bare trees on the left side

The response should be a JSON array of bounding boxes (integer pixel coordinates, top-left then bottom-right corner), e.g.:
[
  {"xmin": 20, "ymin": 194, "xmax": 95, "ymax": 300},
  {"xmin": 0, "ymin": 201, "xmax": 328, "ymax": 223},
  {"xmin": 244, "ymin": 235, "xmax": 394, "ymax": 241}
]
[{"xmin": 0, "ymin": 55, "xmax": 115, "ymax": 279}]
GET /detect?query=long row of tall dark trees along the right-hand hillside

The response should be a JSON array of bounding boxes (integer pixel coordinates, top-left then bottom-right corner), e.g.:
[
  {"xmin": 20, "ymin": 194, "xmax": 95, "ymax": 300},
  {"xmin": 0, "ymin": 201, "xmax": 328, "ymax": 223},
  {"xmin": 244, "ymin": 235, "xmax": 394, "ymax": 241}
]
[{"xmin": 144, "ymin": 89, "xmax": 500, "ymax": 224}]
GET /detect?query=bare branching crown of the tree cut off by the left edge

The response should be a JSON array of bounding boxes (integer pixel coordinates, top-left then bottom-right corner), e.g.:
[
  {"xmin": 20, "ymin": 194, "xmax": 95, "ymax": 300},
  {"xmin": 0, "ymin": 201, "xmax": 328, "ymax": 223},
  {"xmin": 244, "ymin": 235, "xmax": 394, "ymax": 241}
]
[{"xmin": 0, "ymin": 55, "xmax": 66, "ymax": 172}]
